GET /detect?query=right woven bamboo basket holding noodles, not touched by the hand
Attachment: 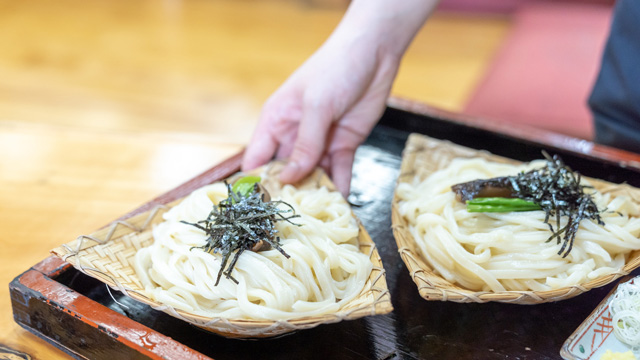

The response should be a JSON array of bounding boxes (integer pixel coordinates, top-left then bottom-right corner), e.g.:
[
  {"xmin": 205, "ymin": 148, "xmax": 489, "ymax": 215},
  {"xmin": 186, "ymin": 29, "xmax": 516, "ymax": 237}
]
[{"xmin": 392, "ymin": 134, "xmax": 640, "ymax": 304}]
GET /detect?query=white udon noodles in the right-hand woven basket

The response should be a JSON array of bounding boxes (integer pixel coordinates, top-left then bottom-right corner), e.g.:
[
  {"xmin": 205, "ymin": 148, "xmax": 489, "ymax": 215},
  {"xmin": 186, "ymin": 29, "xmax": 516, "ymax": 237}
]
[{"xmin": 396, "ymin": 158, "xmax": 640, "ymax": 292}]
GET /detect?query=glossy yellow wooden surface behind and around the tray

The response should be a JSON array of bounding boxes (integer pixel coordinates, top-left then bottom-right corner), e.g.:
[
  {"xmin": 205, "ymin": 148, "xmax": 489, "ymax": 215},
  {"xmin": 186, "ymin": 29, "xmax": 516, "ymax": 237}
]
[{"xmin": 0, "ymin": 0, "xmax": 509, "ymax": 359}]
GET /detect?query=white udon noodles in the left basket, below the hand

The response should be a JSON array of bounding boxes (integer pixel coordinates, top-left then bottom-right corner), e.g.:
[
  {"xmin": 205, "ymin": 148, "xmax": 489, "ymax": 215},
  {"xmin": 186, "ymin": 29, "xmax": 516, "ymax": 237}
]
[{"xmin": 135, "ymin": 183, "xmax": 372, "ymax": 320}]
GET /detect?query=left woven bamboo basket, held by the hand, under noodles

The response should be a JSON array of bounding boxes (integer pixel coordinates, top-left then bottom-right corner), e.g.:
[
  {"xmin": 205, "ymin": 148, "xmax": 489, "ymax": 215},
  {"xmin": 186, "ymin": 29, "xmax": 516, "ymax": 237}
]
[{"xmin": 51, "ymin": 164, "xmax": 393, "ymax": 338}]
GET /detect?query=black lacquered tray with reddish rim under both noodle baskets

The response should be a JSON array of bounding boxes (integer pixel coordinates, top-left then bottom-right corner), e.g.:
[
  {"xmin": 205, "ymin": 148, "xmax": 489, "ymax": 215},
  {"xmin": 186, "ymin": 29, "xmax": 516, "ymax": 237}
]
[{"xmin": 11, "ymin": 102, "xmax": 640, "ymax": 360}]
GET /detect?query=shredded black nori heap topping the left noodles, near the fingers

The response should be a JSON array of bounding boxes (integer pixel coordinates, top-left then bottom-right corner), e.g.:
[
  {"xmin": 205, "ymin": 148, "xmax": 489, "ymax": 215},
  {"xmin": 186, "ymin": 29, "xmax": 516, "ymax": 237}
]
[{"xmin": 182, "ymin": 181, "xmax": 300, "ymax": 286}]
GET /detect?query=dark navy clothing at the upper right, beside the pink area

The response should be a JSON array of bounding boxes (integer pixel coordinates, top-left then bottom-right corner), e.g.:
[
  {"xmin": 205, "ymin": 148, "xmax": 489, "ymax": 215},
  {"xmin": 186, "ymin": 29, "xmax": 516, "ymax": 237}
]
[{"xmin": 589, "ymin": 0, "xmax": 640, "ymax": 153}]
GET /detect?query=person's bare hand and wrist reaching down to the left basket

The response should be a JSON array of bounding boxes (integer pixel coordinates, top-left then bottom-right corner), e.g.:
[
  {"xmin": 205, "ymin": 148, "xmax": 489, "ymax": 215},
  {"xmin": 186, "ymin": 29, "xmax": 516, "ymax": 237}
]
[{"xmin": 242, "ymin": 0, "xmax": 438, "ymax": 197}]
